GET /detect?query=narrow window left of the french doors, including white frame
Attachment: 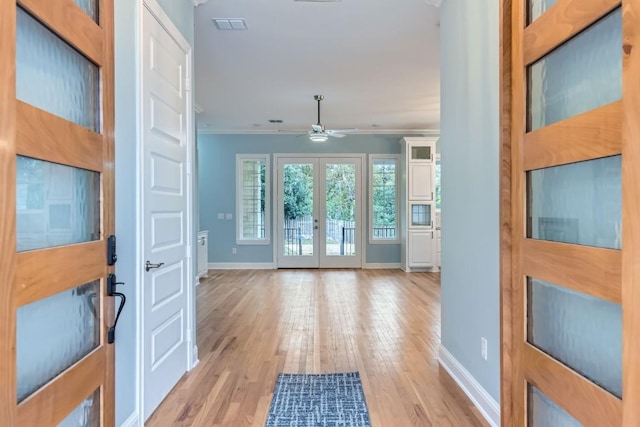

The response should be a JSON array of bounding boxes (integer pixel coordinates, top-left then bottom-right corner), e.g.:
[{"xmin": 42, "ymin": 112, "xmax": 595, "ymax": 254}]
[{"xmin": 236, "ymin": 154, "xmax": 270, "ymax": 245}]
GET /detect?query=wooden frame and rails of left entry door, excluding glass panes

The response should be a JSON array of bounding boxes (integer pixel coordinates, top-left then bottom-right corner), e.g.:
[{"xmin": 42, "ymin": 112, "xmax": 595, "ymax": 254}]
[{"xmin": 0, "ymin": 0, "xmax": 115, "ymax": 426}]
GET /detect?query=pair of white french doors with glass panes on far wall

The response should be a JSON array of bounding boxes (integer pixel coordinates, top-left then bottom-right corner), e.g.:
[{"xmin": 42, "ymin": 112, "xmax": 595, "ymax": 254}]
[{"xmin": 277, "ymin": 156, "xmax": 362, "ymax": 268}]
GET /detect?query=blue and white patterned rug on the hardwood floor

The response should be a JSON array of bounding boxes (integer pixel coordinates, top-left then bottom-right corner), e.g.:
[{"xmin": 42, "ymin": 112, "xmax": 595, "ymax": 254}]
[{"xmin": 266, "ymin": 372, "xmax": 371, "ymax": 427}]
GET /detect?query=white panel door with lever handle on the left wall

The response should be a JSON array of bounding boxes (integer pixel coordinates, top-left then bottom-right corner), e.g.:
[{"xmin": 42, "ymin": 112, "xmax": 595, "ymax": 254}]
[{"xmin": 141, "ymin": 8, "xmax": 190, "ymax": 420}]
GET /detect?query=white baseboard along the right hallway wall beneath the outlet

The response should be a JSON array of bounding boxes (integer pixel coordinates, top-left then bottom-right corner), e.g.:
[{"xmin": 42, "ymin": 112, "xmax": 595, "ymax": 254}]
[{"xmin": 438, "ymin": 345, "xmax": 500, "ymax": 427}]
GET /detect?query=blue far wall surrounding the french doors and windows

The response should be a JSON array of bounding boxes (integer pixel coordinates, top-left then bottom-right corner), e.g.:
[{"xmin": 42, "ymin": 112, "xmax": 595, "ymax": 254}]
[{"xmin": 198, "ymin": 134, "xmax": 402, "ymax": 263}]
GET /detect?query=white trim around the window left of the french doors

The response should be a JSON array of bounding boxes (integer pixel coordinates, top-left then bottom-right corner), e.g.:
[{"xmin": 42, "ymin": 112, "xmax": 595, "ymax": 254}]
[{"xmin": 236, "ymin": 154, "xmax": 271, "ymax": 245}]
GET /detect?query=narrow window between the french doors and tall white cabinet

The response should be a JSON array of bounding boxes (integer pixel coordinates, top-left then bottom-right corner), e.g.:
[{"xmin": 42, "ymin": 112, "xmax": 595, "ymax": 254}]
[{"xmin": 369, "ymin": 154, "xmax": 399, "ymax": 243}]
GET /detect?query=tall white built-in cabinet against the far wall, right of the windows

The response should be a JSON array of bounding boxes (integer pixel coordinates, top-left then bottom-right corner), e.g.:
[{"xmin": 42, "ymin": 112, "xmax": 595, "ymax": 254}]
[{"xmin": 400, "ymin": 137, "xmax": 438, "ymax": 271}]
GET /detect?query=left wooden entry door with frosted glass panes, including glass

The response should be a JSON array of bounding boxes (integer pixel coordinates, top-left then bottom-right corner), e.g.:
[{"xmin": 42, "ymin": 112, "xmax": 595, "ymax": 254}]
[{"xmin": 0, "ymin": 0, "xmax": 114, "ymax": 426}]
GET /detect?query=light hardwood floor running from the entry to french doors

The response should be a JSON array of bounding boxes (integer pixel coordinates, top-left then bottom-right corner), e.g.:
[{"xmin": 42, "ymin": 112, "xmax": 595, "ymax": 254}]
[{"xmin": 147, "ymin": 270, "xmax": 487, "ymax": 427}]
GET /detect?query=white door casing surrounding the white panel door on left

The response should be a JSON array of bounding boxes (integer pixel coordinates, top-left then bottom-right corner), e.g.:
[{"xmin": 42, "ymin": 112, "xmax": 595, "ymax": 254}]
[{"xmin": 135, "ymin": 0, "xmax": 199, "ymax": 425}]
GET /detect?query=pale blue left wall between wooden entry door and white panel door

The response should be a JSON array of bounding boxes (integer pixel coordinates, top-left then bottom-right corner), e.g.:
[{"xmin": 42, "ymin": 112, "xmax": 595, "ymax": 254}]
[{"xmin": 115, "ymin": 0, "xmax": 193, "ymax": 426}]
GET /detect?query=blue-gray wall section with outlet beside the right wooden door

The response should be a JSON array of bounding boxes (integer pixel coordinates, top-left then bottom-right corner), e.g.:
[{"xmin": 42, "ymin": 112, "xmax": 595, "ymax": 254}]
[{"xmin": 440, "ymin": 0, "xmax": 500, "ymax": 400}]
